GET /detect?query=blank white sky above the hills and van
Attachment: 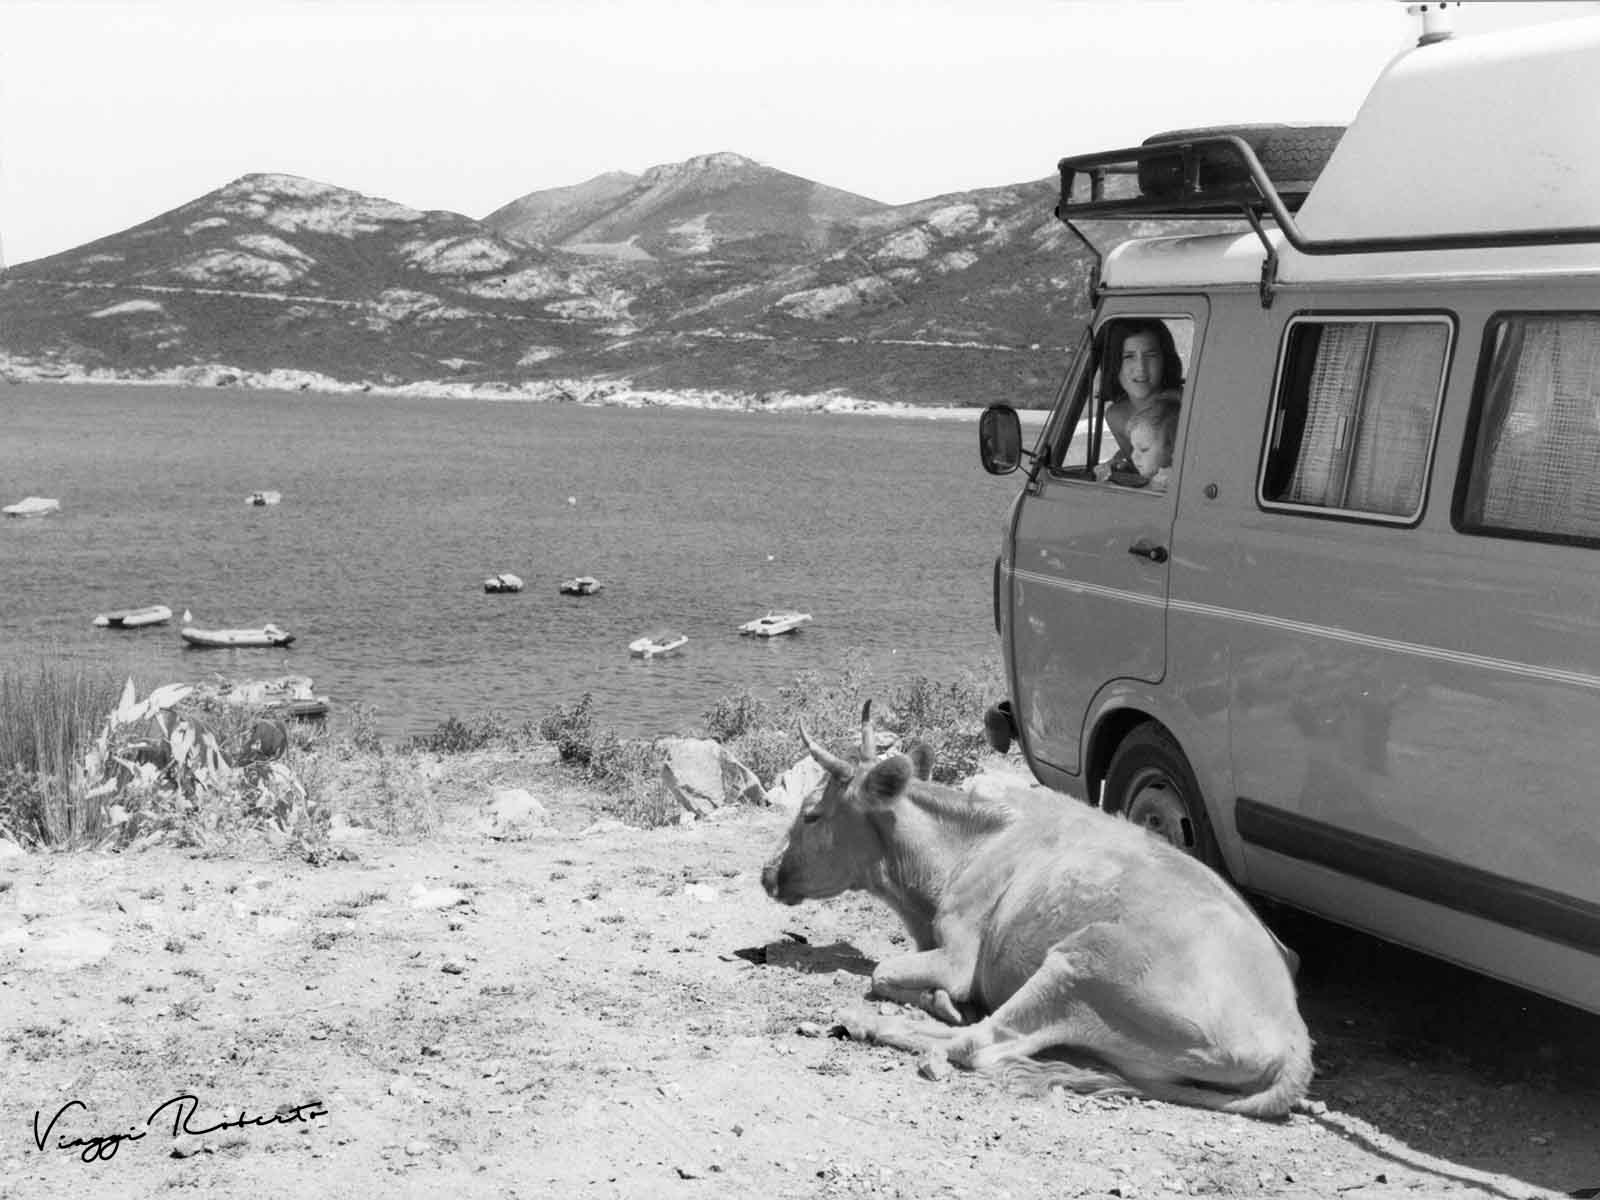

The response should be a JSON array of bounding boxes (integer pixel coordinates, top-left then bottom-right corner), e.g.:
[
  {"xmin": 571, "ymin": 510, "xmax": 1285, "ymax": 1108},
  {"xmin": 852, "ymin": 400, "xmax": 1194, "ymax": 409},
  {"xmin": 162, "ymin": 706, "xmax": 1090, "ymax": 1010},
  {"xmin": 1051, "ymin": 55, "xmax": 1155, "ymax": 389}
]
[{"xmin": 0, "ymin": 0, "xmax": 1600, "ymax": 264}]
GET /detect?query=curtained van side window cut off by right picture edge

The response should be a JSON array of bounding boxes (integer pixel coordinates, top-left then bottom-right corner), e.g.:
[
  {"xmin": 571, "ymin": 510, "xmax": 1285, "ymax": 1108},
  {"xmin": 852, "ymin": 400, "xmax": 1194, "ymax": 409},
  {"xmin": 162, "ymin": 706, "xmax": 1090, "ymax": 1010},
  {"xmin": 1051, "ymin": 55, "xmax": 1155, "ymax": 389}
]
[{"xmin": 1458, "ymin": 314, "xmax": 1600, "ymax": 544}]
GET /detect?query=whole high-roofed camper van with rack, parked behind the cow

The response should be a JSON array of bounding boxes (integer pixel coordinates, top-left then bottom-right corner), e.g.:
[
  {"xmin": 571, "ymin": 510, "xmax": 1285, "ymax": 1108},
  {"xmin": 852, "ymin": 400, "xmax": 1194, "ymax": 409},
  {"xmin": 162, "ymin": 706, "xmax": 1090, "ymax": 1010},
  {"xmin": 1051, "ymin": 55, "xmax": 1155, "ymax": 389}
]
[{"xmin": 979, "ymin": 19, "xmax": 1600, "ymax": 1013}]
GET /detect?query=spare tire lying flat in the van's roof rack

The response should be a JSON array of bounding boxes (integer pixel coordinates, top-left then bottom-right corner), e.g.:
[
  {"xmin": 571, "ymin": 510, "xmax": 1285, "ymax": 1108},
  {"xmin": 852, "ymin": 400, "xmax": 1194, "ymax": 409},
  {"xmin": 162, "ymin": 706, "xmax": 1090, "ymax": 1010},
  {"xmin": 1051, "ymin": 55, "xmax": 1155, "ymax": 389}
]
[{"xmin": 1139, "ymin": 125, "xmax": 1344, "ymax": 205}]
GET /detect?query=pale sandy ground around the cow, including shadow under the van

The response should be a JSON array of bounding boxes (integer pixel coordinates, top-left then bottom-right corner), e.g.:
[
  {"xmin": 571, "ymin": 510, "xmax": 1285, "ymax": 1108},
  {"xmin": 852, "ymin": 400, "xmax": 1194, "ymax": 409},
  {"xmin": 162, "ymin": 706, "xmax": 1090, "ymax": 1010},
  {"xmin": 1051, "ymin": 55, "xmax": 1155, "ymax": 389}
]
[{"xmin": 0, "ymin": 760, "xmax": 1600, "ymax": 1200}]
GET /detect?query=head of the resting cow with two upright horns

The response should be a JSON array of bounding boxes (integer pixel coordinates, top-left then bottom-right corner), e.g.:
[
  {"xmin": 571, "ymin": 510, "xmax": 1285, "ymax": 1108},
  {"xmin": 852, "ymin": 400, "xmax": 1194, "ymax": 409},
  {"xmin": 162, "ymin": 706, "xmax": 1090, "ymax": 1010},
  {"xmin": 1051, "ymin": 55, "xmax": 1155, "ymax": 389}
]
[{"xmin": 762, "ymin": 701, "xmax": 931, "ymax": 904}]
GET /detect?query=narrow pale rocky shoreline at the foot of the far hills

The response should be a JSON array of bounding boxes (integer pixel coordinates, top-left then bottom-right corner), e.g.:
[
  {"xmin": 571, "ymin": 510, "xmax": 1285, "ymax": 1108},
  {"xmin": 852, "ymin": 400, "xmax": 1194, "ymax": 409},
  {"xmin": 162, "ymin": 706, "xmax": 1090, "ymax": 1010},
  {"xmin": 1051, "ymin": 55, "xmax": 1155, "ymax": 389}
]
[{"xmin": 0, "ymin": 355, "xmax": 1045, "ymax": 421}]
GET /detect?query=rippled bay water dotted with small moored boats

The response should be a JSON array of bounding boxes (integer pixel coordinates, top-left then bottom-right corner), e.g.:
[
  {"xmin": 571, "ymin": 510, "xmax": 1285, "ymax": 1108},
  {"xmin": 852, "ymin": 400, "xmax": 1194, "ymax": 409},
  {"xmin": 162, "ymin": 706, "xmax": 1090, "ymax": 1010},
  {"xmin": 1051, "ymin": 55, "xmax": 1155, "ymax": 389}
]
[{"xmin": 0, "ymin": 384, "xmax": 1018, "ymax": 738}]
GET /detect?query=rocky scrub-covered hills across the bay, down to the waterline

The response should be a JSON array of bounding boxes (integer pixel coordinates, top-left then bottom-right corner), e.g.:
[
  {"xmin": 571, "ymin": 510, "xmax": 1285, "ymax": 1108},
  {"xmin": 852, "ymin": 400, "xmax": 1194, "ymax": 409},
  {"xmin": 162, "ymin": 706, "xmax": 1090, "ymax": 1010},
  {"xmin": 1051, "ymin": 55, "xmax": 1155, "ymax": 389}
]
[{"xmin": 0, "ymin": 154, "xmax": 1086, "ymax": 405}]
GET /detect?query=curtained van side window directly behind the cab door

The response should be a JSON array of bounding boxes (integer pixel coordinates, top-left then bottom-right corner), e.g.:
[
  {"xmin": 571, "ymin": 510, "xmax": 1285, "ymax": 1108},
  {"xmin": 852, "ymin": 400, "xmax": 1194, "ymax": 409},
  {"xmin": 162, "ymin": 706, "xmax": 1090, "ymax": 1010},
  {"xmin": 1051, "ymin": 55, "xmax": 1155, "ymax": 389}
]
[{"xmin": 1259, "ymin": 317, "xmax": 1451, "ymax": 523}]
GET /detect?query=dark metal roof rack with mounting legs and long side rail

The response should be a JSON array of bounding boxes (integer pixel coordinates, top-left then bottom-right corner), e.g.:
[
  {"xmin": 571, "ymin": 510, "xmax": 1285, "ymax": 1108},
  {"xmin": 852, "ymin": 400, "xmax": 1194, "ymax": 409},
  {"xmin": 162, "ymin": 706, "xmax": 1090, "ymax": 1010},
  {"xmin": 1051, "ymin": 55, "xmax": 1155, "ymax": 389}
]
[{"xmin": 1056, "ymin": 133, "xmax": 1600, "ymax": 307}]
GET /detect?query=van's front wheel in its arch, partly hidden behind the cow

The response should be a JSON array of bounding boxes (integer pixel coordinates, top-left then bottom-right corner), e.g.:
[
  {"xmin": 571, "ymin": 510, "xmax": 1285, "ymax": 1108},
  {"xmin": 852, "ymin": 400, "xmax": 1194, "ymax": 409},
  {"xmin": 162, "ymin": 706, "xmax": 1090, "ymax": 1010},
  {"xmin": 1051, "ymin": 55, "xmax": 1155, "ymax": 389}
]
[{"xmin": 1101, "ymin": 722, "xmax": 1227, "ymax": 877}]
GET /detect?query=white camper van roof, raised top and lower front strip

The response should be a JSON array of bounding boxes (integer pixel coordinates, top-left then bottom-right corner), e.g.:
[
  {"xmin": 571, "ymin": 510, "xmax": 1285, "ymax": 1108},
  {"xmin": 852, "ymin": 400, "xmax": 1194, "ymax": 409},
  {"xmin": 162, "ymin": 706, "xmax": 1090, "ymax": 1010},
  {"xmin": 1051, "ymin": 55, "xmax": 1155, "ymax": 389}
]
[{"xmin": 1102, "ymin": 18, "xmax": 1600, "ymax": 288}]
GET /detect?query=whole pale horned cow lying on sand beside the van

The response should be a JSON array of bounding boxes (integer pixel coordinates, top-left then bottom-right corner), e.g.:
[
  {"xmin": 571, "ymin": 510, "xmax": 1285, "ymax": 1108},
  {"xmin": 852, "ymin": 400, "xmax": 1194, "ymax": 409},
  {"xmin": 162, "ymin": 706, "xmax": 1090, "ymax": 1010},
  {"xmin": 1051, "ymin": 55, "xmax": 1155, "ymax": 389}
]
[{"xmin": 762, "ymin": 704, "xmax": 1312, "ymax": 1117}]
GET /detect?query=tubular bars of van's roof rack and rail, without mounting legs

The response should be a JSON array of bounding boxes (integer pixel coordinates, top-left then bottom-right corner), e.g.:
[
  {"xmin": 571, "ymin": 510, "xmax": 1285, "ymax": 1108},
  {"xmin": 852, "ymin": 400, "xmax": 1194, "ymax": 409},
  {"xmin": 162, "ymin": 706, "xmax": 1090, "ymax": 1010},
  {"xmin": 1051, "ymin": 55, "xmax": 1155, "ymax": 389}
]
[{"xmin": 1056, "ymin": 134, "xmax": 1600, "ymax": 254}]
